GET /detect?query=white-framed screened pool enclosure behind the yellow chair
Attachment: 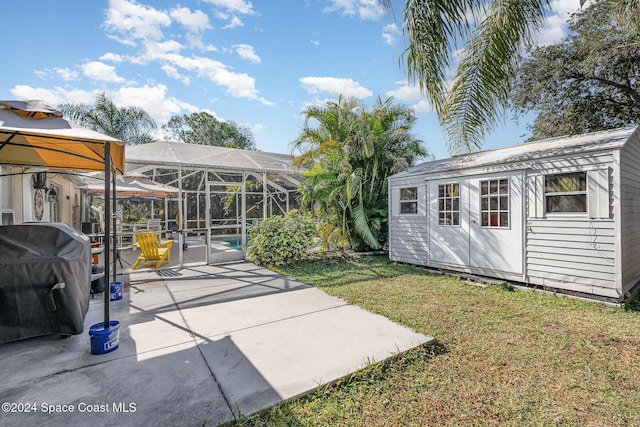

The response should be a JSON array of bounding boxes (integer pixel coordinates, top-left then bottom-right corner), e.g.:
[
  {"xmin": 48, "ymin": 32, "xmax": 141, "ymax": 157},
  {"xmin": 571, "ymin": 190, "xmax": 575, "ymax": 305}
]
[{"xmin": 126, "ymin": 141, "xmax": 300, "ymax": 265}]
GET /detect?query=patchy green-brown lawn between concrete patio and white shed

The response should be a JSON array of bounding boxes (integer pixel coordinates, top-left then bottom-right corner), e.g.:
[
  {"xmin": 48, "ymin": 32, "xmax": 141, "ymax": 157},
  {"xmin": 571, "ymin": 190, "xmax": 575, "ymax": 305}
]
[{"xmin": 228, "ymin": 256, "xmax": 640, "ymax": 426}]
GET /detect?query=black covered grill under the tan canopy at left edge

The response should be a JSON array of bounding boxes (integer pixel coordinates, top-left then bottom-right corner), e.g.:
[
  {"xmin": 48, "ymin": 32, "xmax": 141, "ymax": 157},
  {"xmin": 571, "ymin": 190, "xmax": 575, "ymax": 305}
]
[{"xmin": 0, "ymin": 223, "xmax": 91, "ymax": 343}]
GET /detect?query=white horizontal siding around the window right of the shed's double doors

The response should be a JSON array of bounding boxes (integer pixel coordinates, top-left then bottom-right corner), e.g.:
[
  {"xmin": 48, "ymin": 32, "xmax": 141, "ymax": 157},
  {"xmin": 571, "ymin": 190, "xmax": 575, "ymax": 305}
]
[{"xmin": 526, "ymin": 153, "xmax": 619, "ymax": 298}]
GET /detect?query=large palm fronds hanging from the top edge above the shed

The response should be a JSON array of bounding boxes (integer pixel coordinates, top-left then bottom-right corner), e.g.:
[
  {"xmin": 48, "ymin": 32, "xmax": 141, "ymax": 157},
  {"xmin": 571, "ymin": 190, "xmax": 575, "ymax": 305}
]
[{"xmin": 378, "ymin": 0, "xmax": 640, "ymax": 154}]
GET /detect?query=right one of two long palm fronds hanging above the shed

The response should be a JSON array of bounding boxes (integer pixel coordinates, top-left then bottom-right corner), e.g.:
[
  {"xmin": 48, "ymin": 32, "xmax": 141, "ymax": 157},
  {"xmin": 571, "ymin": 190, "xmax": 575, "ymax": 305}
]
[{"xmin": 440, "ymin": 0, "xmax": 548, "ymax": 154}]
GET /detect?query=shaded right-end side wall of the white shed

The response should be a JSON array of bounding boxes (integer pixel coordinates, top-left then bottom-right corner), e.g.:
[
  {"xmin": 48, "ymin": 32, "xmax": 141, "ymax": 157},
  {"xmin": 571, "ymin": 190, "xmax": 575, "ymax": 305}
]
[{"xmin": 616, "ymin": 133, "xmax": 640, "ymax": 294}]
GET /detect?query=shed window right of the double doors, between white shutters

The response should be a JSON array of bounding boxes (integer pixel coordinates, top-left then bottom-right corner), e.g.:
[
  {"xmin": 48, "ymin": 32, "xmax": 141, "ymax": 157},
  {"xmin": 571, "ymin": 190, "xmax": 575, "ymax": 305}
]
[{"xmin": 544, "ymin": 172, "xmax": 587, "ymax": 213}]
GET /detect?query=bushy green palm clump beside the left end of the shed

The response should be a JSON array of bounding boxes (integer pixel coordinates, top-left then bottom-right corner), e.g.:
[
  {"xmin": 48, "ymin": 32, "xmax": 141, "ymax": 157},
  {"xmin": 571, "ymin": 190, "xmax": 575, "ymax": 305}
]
[{"xmin": 293, "ymin": 95, "xmax": 426, "ymax": 250}]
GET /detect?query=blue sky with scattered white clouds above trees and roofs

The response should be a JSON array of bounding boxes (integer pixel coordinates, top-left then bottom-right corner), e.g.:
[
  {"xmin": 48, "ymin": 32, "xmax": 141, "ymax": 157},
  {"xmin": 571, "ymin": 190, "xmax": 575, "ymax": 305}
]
[{"xmin": 0, "ymin": 0, "xmax": 579, "ymax": 158}]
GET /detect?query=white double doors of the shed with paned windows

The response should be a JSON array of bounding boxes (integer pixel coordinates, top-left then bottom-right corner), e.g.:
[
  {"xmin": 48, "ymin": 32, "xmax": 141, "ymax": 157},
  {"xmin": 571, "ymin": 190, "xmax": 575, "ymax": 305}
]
[{"xmin": 429, "ymin": 172, "xmax": 523, "ymax": 274}]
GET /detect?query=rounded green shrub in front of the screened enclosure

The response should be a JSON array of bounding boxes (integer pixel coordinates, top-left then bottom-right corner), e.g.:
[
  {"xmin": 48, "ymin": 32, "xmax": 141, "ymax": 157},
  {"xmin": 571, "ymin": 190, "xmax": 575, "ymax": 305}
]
[{"xmin": 247, "ymin": 209, "xmax": 317, "ymax": 265}]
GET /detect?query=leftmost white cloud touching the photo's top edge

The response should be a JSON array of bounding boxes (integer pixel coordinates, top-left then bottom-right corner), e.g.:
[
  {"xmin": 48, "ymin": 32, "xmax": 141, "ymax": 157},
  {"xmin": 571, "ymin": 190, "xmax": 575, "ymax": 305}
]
[{"xmin": 105, "ymin": 0, "xmax": 171, "ymax": 40}]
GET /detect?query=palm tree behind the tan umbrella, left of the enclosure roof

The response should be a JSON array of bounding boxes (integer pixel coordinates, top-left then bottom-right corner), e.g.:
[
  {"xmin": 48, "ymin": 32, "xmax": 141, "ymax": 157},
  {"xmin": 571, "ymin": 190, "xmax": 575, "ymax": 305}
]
[{"xmin": 59, "ymin": 93, "xmax": 157, "ymax": 145}]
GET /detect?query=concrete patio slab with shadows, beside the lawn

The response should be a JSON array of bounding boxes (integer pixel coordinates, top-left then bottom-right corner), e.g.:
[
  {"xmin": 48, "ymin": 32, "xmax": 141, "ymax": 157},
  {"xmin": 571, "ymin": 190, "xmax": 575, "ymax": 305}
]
[{"xmin": 0, "ymin": 262, "xmax": 432, "ymax": 427}]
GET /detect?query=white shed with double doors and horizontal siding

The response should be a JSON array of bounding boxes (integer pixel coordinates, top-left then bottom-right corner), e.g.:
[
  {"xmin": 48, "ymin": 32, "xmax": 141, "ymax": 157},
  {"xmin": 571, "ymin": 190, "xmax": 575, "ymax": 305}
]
[{"xmin": 389, "ymin": 128, "xmax": 640, "ymax": 301}]
